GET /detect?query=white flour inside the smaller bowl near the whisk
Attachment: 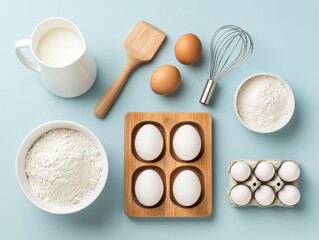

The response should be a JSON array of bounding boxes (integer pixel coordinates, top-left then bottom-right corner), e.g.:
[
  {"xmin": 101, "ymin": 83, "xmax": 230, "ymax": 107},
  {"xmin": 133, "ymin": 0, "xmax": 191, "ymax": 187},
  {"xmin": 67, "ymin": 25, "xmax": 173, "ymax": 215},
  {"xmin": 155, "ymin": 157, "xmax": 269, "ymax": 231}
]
[{"xmin": 236, "ymin": 75, "xmax": 292, "ymax": 132}]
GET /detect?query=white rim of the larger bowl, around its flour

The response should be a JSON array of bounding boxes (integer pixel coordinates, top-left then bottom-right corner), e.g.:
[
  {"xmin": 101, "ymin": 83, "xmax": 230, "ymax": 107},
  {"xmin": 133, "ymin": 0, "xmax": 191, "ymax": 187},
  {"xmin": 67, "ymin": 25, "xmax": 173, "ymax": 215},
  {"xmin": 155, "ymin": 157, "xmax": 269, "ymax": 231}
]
[{"xmin": 16, "ymin": 121, "xmax": 108, "ymax": 214}]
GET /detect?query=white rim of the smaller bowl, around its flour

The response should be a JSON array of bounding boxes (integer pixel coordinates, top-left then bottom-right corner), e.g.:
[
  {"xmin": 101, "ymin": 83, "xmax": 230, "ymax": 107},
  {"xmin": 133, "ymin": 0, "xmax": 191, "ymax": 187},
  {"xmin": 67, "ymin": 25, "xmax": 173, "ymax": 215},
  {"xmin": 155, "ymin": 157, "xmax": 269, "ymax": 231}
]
[{"xmin": 234, "ymin": 73, "xmax": 295, "ymax": 133}]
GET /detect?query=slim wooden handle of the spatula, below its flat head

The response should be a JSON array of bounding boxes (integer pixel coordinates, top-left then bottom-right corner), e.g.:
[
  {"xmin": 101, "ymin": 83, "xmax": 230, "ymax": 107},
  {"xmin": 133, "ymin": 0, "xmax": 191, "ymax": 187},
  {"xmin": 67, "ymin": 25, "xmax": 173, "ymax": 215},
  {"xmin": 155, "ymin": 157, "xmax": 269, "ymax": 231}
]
[{"xmin": 94, "ymin": 54, "xmax": 143, "ymax": 118}]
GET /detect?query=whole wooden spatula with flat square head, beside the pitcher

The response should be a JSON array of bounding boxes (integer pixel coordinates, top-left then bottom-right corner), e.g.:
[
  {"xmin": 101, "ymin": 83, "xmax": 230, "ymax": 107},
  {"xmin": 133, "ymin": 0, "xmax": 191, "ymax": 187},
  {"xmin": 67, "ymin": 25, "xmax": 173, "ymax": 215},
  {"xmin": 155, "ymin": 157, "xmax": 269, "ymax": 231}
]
[{"xmin": 94, "ymin": 21, "xmax": 166, "ymax": 118}]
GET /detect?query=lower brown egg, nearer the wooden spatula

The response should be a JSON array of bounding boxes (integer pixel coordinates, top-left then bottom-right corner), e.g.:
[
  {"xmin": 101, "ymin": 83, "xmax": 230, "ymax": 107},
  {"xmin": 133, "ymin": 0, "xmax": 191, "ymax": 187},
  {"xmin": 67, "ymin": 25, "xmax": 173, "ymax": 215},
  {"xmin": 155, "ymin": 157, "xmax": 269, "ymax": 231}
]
[{"xmin": 151, "ymin": 65, "xmax": 181, "ymax": 95}]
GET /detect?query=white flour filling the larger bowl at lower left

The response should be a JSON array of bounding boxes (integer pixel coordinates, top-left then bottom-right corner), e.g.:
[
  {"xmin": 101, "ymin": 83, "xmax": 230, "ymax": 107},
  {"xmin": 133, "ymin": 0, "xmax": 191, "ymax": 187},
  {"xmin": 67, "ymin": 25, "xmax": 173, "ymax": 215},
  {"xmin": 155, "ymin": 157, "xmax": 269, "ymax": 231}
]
[{"xmin": 25, "ymin": 128, "xmax": 102, "ymax": 205}]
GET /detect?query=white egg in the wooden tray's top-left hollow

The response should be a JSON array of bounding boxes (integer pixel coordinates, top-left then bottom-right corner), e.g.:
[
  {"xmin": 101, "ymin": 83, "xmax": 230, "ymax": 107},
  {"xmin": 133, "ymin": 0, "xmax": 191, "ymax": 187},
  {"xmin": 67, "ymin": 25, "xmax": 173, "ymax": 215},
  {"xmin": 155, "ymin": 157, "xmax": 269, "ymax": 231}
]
[{"xmin": 134, "ymin": 124, "xmax": 164, "ymax": 161}]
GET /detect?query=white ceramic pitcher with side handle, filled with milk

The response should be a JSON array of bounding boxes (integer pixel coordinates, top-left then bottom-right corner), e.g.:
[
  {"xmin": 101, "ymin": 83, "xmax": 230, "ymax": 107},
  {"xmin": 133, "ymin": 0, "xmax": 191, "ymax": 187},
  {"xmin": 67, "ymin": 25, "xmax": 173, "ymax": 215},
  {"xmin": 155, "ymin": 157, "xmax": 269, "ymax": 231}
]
[{"xmin": 15, "ymin": 17, "xmax": 97, "ymax": 98}]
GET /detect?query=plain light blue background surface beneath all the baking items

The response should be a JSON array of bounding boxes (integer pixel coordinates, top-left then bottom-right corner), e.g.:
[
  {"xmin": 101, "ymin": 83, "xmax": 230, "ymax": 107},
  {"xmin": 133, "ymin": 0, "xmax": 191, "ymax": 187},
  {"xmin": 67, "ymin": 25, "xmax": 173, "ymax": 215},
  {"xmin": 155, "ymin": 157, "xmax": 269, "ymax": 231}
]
[{"xmin": 0, "ymin": 0, "xmax": 319, "ymax": 240}]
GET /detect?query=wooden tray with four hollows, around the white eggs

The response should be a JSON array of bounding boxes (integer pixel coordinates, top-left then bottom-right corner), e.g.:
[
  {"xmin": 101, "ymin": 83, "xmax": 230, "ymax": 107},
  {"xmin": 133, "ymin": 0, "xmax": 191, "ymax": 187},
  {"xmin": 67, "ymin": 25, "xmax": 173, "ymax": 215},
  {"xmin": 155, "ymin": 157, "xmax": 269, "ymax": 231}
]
[{"xmin": 124, "ymin": 113, "xmax": 212, "ymax": 217}]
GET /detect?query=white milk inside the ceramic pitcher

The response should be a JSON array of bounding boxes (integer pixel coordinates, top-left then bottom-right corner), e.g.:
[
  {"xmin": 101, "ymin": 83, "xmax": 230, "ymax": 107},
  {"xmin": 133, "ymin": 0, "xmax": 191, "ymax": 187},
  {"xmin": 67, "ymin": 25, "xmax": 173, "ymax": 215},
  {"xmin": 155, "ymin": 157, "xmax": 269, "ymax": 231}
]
[{"xmin": 36, "ymin": 28, "xmax": 84, "ymax": 67}]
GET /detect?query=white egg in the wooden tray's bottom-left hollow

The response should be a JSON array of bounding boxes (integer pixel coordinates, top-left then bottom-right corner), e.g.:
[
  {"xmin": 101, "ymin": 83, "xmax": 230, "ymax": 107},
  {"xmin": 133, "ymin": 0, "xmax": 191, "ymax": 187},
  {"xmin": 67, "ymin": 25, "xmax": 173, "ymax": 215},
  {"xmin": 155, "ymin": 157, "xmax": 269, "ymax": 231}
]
[{"xmin": 134, "ymin": 169, "xmax": 164, "ymax": 207}]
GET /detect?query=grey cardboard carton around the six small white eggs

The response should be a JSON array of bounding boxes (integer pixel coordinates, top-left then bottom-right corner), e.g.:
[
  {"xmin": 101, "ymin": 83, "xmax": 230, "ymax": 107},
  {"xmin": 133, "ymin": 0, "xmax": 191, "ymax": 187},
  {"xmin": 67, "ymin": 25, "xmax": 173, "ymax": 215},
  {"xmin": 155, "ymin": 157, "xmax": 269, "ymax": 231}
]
[{"xmin": 227, "ymin": 159, "xmax": 299, "ymax": 208}]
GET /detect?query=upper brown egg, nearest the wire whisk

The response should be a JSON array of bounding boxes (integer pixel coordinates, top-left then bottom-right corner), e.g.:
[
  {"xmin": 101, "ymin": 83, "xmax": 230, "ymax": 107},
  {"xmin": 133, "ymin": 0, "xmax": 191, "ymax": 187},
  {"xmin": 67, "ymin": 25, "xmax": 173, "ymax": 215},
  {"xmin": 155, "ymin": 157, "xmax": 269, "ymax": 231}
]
[{"xmin": 174, "ymin": 33, "xmax": 202, "ymax": 65}]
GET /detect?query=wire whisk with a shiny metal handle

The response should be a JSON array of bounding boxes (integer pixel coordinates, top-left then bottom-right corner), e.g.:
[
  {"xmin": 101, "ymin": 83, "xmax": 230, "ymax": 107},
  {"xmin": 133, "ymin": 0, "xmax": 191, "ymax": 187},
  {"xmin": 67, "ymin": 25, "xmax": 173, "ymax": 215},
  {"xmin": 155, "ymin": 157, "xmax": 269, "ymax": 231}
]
[{"xmin": 200, "ymin": 25, "xmax": 254, "ymax": 105}]
